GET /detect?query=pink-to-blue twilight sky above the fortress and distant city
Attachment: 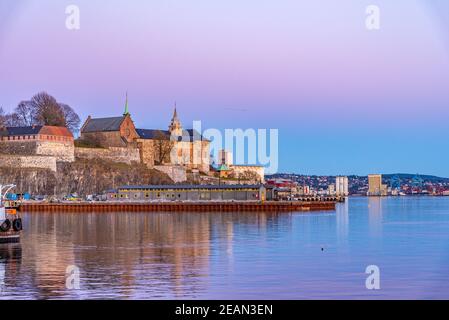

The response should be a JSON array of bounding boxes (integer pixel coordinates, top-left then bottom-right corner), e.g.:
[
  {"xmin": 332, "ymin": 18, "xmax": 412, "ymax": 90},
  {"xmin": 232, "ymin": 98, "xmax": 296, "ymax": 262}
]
[{"xmin": 0, "ymin": 0, "xmax": 449, "ymax": 177}]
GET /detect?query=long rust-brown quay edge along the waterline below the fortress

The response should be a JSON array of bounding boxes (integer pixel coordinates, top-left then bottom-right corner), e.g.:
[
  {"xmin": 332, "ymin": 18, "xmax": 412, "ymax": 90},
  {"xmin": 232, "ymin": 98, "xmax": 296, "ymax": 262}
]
[{"xmin": 20, "ymin": 201, "xmax": 336, "ymax": 213}]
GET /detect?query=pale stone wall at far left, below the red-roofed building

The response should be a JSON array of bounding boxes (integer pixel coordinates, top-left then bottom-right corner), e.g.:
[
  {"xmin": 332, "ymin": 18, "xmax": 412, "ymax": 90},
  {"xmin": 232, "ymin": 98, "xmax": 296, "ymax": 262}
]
[{"xmin": 0, "ymin": 154, "xmax": 56, "ymax": 172}]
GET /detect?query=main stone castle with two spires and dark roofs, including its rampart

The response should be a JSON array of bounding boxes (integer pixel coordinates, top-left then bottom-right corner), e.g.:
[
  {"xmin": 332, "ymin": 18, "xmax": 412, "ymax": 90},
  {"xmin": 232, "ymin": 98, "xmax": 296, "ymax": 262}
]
[{"xmin": 75, "ymin": 106, "xmax": 210, "ymax": 182}]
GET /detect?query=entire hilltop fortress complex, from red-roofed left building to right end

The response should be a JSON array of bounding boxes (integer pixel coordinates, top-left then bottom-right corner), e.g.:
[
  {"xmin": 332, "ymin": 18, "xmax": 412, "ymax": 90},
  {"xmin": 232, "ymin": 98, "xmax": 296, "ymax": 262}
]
[{"xmin": 0, "ymin": 99, "xmax": 264, "ymax": 183}]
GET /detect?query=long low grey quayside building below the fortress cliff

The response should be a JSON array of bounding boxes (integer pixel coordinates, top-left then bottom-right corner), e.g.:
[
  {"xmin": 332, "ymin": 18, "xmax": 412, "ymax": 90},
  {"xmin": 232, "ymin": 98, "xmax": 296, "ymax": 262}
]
[{"xmin": 107, "ymin": 185, "xmax": 266, "ymax": 201}]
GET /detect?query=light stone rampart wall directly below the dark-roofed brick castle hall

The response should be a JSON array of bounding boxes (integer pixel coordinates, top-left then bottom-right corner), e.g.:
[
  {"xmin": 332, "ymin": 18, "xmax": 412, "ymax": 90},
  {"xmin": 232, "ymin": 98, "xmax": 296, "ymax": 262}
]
[{"xmin": 75, "ymin": 147, "xmax": 140, "ymax": 164}]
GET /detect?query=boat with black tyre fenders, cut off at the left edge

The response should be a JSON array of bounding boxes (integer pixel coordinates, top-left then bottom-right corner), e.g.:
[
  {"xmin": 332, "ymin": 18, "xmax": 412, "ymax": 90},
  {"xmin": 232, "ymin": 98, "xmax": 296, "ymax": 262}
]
[{"xmin": 0, "ymin": 185, "xmax": 22, "ymax": 243}]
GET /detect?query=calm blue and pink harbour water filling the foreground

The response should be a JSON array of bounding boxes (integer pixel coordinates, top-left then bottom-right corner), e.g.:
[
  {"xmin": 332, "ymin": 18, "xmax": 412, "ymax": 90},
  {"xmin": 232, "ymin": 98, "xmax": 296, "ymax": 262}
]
[{"xmin": 0, "ymin": 197, "xmax": 449, "ymax": 299}]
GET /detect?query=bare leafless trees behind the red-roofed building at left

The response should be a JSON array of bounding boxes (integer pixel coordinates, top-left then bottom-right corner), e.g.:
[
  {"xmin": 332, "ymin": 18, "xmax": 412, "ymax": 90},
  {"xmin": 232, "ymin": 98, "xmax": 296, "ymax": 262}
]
[{"xmin": 0, "ymin": 92, "xmax": 81, "ymax": 133}]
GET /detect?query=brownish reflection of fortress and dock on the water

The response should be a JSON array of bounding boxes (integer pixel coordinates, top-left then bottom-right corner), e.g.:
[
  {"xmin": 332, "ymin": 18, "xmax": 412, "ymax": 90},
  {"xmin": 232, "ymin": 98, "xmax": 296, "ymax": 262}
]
[{"xmin": 9, "ymin": 213, "xmax": 289, "ymax": 299}]
